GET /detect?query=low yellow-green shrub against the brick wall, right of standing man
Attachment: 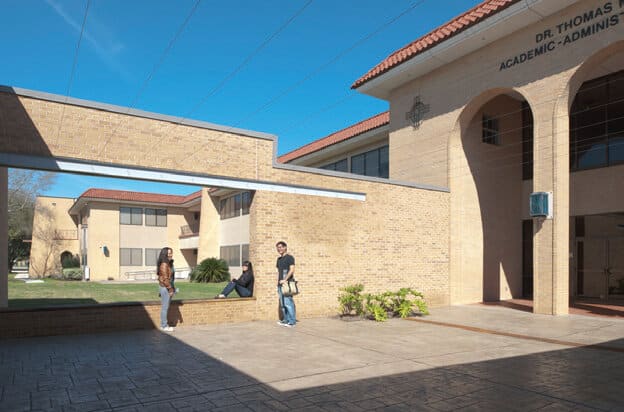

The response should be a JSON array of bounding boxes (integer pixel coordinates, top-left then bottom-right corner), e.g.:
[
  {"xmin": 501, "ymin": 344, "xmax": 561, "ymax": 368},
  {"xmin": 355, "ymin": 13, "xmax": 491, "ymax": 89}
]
[{"xmin": 338, "ymin": 284, "xmax": 429, "ymax": 322}]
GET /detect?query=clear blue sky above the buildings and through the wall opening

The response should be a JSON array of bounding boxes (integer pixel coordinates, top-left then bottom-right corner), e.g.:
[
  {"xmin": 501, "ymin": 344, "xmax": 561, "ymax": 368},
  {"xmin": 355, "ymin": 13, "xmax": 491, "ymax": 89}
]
[{"xmin": 0, "ymin": 0, "xmax": 480, "ymax": 197}]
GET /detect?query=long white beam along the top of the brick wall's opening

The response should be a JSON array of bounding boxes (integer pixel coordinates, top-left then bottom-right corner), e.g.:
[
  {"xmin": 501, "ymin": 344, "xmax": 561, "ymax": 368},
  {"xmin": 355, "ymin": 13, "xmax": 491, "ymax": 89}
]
[{"xmin": 0, "ymin": 153, "xmax": 366, "ymax": 201}]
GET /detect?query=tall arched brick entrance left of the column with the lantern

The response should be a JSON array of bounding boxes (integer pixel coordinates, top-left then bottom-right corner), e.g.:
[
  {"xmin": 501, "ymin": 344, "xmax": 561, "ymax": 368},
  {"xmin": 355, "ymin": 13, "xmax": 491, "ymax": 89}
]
[{"xmin": 449, "ymin": 89, "xmax": 533, "ymax": 303}]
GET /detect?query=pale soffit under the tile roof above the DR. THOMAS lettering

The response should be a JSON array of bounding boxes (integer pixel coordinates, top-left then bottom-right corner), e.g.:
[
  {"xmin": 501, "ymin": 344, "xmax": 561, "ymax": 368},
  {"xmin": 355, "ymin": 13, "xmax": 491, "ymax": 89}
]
[{"xmin": 356, "ymin": 0, "xmax": 578, "ymax": 100}]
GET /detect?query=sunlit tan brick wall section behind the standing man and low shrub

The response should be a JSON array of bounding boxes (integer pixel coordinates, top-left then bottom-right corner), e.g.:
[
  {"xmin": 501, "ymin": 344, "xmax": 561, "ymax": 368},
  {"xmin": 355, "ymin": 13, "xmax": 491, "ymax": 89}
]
[{"xmin": 245, "ymin": 177, "xmax": 449, "ymax": 318}]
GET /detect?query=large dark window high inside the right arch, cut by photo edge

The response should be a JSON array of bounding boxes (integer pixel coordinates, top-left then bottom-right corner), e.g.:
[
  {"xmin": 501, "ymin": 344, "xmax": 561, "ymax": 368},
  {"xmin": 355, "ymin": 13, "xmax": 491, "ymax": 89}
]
[{"xmin": 570, "ymin": 70, "xmax": 624, "ymax": 170}]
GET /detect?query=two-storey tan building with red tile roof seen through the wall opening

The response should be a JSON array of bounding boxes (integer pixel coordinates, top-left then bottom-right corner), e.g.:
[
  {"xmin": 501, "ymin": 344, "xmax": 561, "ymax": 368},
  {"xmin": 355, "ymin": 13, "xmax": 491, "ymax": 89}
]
[{"xmin": 30, "ymin": 189, "xmax": 251, "ymax": 281}]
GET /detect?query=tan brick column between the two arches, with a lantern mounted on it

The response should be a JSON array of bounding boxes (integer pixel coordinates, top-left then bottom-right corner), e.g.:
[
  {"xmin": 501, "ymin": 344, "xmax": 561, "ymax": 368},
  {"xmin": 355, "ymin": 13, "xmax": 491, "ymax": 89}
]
[{"xmin": 527, "ymin": 103, "xmax": 570, "ymax": 315}]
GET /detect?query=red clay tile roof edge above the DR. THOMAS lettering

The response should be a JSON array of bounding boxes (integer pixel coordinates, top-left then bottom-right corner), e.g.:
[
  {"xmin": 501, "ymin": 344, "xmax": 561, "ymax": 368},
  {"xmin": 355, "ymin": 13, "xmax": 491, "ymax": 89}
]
[{"xmin": 351, "ymin": 0, "xmax": 521, "ymax": 89}]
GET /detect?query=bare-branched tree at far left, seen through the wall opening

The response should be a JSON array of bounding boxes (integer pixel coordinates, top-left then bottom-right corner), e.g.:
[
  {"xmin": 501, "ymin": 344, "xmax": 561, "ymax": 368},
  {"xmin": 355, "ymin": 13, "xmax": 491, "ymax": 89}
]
[{"xmin": 7, "ymin": 169, "xmax": 56, "ymax": 272}]
